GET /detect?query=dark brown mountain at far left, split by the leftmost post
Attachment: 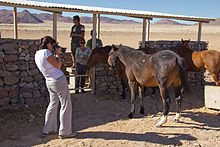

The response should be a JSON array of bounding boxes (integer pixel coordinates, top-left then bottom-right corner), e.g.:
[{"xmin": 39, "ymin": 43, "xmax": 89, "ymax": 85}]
[{"xmin": 0, "ymin": 10, "xmax": 43, "ymax": 24}]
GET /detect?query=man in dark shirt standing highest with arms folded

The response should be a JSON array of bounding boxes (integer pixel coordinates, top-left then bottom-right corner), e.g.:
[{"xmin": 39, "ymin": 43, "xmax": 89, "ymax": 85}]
[{"xmin": 70, "ymin": 15, "xmax": 85, "ymax": 67}]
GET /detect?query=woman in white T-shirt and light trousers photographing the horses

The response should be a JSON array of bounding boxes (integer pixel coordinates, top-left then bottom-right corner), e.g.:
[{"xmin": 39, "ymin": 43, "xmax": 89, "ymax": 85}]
[{"xmin": 35, "ymin": 36, "xmax": 76, "ymax": 139}]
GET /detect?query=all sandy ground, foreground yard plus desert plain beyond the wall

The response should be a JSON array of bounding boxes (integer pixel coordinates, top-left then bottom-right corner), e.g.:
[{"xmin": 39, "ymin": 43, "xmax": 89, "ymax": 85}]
[{"xmin": 0, "ymin": 22, "xmax": 220, "ymax": 147}]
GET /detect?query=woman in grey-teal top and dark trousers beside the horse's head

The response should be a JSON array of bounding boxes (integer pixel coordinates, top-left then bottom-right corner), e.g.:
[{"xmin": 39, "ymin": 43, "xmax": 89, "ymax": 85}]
[{"xmin": 75, "ymin": 39, "xmax": 92, "ymax": 94}]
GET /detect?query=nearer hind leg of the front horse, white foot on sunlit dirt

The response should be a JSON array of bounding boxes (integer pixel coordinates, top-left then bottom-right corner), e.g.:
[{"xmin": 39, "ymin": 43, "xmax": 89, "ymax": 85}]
[{"xmin": 156, "ymin": 87, "xmax": 171, "ymax": 127}]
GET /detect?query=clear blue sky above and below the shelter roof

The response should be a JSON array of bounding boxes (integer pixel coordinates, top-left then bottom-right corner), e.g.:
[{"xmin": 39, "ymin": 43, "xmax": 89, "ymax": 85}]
[{"xmin": 0, "ymin": 0, "xmax": 220, "ymax": 23}]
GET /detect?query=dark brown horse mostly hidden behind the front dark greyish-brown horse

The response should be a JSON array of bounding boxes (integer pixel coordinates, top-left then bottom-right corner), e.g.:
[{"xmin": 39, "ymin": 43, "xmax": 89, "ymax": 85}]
[{"xmin": 87, "ymin": 46, "xmax": 156, "ymax": 99}]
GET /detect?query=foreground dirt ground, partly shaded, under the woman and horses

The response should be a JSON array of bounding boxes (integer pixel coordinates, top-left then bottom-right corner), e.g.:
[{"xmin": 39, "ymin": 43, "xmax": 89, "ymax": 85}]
[{"xmin": 0, "ymin": 85, "xmax": 220, "ymax": 147}]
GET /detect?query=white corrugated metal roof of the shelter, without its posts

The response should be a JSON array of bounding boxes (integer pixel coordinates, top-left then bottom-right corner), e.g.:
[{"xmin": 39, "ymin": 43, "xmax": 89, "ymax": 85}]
[{"xmin": 0, "ymin": 0, "xmax": 215, "ymax": 22}]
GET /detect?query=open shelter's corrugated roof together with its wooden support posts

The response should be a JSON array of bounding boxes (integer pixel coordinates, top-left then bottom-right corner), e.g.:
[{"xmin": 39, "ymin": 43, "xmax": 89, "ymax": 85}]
[{"xmin": 0, "ymin": 0, "xmax": 215, "ymax": 94}]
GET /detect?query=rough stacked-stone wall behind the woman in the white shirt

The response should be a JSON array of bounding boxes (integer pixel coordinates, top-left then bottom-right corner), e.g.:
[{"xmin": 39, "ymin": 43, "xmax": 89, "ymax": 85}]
[{"xmin": 0, "ymin": 38, "xmax": 72, "ymax": 104}]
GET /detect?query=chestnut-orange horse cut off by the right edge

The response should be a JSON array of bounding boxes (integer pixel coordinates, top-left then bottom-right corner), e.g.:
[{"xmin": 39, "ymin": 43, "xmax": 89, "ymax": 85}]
[{"xmin": 180, "ymin": 39, "xmax": 220, "ymax": 86}]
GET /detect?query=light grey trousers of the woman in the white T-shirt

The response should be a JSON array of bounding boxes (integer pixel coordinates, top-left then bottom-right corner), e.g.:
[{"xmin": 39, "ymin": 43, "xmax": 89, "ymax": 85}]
[{"xmin": 42, "ymin": 75, "xmax": 72, "ymax": 135}]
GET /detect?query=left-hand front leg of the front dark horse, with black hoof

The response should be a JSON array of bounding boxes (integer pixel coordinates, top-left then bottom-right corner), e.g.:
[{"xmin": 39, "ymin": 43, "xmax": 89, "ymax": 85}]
[{"xmin": 128, "ymin": 81, "xmax": 136, "ymax": 118}]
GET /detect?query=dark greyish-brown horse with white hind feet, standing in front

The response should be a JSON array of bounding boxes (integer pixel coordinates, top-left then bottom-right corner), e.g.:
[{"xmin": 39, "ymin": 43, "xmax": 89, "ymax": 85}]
[{"xmin": 108, "ymin": 45, "xmax": 187, "ymax": 126}]
